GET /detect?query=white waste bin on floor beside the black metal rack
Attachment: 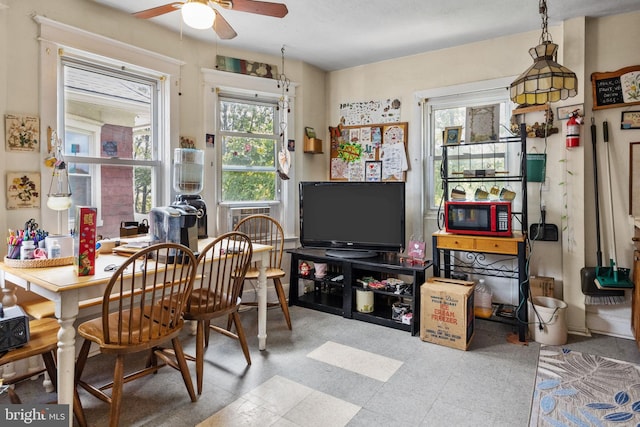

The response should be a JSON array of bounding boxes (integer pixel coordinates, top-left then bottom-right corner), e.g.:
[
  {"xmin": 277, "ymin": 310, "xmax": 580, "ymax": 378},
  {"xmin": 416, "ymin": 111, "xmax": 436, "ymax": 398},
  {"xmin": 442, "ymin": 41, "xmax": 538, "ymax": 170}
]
[{"xmin": 528, "ymin": 297, "xmax": 567, "ymax": 345}]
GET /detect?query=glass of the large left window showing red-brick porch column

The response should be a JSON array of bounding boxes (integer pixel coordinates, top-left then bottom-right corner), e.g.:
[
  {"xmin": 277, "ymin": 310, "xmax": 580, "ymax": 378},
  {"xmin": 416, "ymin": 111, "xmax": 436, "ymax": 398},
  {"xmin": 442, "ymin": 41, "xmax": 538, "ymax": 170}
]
[{"xmin": 61, "ymin": 55, "xmax": 160, "ymax": 237}]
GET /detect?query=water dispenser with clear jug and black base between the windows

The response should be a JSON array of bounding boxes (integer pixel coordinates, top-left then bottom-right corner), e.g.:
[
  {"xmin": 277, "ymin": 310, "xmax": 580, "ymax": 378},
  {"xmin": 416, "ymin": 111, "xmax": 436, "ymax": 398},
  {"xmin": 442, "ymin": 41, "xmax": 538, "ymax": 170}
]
[{"xmin": 171, "ymin": 148, "xmax": 208, "ymax": 239}]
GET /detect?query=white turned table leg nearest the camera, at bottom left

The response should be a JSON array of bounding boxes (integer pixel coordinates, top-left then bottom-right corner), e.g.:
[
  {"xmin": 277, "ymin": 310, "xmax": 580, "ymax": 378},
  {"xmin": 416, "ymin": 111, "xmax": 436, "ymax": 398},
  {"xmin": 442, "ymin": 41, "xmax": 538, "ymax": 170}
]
[{"xmin": 56, "ymin": 291, "xmax": 78, "ymax": 427}]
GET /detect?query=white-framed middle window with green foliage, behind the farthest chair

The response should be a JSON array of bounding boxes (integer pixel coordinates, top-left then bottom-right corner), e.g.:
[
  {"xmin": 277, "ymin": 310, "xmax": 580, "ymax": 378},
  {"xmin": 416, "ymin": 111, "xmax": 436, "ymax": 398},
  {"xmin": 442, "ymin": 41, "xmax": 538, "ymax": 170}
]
[{"xmin": 203, "ymin": 70, "xmax": 297, "ymax": 237}]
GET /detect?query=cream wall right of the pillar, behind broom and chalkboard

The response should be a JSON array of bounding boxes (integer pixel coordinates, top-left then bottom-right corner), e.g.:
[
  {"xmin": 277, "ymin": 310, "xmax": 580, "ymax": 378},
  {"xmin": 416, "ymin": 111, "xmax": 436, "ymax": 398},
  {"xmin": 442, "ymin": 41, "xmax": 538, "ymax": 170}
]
[{"xmin": 583, "ymin": 13, "xmax": 640, "ymax": 335}]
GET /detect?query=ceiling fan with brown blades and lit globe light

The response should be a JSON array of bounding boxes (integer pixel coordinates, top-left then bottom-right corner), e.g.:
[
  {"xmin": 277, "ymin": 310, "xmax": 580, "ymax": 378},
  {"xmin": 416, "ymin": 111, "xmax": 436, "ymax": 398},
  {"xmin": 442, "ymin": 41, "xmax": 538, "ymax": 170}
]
[{"xmin": 133, "ymin": 0, "xmax": 289, "ymax": 40}]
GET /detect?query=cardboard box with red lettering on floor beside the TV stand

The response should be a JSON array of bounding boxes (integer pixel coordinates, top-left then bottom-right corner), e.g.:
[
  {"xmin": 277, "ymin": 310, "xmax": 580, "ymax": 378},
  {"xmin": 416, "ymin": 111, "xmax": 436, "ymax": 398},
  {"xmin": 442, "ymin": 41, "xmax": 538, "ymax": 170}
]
[{"xmin": 420, "ymin": 277, "xmax": 475, "ymax": 350}]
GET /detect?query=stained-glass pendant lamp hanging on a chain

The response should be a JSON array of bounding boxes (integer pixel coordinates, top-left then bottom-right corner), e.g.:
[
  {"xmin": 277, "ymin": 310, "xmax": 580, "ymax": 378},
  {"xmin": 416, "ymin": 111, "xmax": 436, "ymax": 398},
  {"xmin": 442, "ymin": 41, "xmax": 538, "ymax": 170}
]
[{"xmin": 511, "ymin": 0, "xmax": 578, "ymax": 105}]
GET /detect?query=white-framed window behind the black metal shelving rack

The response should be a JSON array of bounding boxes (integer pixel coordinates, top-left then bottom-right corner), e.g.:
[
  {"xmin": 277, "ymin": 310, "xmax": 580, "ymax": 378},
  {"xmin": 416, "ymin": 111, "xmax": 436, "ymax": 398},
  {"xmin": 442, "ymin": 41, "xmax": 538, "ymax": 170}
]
[{"xmin": 424, "ymin": 83, "xmax": 517, "ymax": 209}]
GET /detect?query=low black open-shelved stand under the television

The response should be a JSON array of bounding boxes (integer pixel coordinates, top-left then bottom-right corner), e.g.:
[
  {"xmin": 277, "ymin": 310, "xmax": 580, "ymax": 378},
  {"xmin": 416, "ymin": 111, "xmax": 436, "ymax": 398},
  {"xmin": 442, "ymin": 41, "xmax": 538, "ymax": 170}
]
[{"xmin": 287, "ymin": 248, "xmax": 432, "ymax": 335}]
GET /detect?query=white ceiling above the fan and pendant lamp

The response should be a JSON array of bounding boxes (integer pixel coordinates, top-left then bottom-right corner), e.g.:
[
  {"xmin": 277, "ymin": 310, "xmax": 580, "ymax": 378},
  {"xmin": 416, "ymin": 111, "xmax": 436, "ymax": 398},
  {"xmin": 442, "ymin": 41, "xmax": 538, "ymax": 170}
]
[{"xmin": 90, "ymin": 0, "xmax": 640, "ymax": 71}]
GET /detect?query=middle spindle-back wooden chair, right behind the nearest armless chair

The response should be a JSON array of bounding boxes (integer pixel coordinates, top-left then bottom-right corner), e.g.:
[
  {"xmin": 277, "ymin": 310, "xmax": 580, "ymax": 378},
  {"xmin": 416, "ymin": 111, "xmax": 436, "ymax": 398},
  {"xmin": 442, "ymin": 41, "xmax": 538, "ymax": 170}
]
[{"xmin": 184, "ymin": 232, "xmax": 253, "ymax": 394}]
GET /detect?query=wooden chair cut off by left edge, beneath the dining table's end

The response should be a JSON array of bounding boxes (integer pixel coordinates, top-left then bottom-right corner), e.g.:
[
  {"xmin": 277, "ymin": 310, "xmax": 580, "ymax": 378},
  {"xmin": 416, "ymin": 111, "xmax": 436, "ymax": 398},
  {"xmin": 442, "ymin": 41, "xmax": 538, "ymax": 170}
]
[{"xmin": 0, "ymin": 318, "xmax": 87, "ymax": 426}]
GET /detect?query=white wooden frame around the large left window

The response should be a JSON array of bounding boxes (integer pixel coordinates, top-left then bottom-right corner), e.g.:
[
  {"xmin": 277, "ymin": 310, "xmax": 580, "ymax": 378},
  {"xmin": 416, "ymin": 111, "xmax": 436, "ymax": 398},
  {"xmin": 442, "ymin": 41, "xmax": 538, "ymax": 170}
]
[{"xmin": 34, "ymin": 15, "xmax": 183, "ymax": 232}]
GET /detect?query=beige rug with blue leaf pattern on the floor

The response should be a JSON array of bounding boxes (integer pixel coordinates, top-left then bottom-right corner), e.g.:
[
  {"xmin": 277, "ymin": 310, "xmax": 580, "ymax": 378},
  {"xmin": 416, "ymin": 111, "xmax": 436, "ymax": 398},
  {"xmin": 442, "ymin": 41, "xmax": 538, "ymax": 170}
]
[{"xmin": 529, "ymin": 347, "xmax": 640, "ymax": 427}]
